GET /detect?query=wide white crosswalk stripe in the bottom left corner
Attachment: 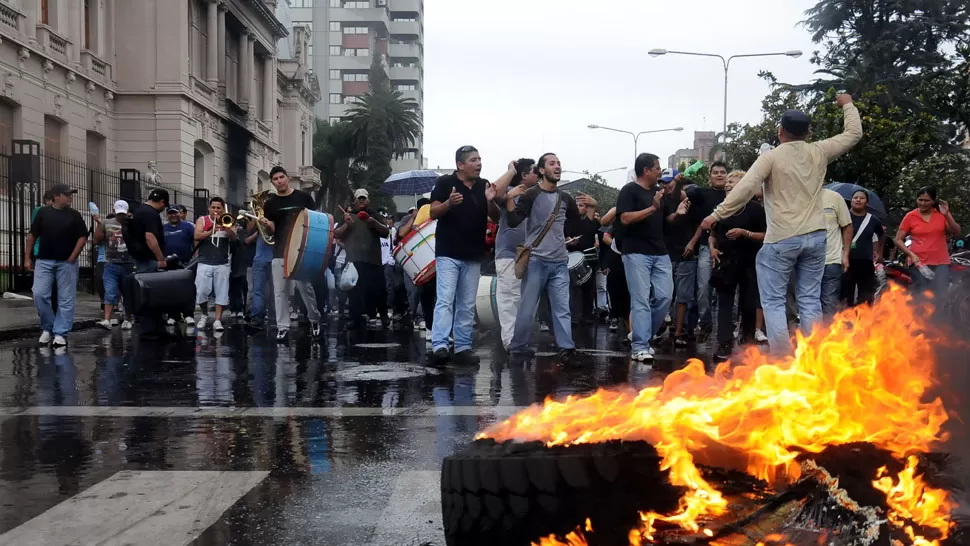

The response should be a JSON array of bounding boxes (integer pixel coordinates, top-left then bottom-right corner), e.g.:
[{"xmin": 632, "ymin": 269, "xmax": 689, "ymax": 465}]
[{"xmin": 0, "ymin": 471, "xmax": 269, "ymax": 546}]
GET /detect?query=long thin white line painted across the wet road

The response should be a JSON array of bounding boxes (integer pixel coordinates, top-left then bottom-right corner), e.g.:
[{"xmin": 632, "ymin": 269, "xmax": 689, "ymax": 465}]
[{"xmin": 0, "ymin": 406, "xmax": 525, "ymax": 420}]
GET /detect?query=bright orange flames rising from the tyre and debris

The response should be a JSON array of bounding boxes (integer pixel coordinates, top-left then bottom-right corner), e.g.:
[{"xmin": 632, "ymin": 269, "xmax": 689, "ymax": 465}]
[{"xmin": 478, "ymin": 290, "xmax": 952, "ymax": 544}]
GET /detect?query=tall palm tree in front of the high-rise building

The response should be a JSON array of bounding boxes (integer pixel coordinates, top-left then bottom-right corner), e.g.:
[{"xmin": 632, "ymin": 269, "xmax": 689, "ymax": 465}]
[{"xmin": 347, "ymin": 55, "xmax": 422, "ymax": 212}]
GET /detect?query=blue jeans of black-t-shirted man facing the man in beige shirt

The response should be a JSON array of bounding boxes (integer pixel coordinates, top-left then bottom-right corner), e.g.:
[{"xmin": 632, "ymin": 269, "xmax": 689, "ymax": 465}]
[{"xmin": 623, "ymin": 254, "xmax": 674, "ymax": 352}]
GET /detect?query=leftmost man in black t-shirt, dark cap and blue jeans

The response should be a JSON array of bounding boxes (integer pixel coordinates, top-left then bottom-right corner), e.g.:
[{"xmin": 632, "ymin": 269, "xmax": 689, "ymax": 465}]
[{"xmin": 24, "ymin": 184, "xmax": 88, "ymax": 347}]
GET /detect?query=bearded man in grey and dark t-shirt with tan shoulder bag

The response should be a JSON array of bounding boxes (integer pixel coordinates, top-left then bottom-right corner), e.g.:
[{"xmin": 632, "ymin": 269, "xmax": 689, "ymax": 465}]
[{"xmin": 505, "ymin": 153, "xmax": 589, "ymax": 364}]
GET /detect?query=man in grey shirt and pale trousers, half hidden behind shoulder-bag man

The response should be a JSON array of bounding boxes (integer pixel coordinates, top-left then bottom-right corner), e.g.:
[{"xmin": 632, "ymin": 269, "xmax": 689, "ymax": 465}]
[{"xmin": 495, "ymin": 158, "xmax": 539, "ymax": 351}]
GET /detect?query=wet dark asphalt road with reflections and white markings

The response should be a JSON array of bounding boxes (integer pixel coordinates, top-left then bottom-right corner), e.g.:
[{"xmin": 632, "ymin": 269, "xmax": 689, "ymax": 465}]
[{"xmin": 0, "ymin": 321, "xmax": 706, "ymax": 546}]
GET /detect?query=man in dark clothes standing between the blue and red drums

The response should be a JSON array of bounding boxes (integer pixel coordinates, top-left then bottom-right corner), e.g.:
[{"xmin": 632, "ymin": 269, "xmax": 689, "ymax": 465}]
[{"xmin": 334, "ymin": 188, "xmax": 391, "ymax": 328}]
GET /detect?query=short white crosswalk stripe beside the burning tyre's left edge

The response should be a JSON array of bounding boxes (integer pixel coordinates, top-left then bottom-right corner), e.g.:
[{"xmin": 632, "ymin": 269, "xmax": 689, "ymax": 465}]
[{"xmin": 370, "ymin": 471, "xmax": 444, "ymax": 546}]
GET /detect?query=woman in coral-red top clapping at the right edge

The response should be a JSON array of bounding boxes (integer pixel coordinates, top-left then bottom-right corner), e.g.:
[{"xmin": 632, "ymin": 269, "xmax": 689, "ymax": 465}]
[{"xmin": 895, "ymin": 186, "xmax": 960, "ymax": 294}]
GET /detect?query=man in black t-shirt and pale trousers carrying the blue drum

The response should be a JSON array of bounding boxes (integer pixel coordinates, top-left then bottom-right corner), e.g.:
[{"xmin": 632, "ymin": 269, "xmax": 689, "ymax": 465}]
[{"xmin": 259, "ymin": 165, "xmax": 321, "ymax": 341}]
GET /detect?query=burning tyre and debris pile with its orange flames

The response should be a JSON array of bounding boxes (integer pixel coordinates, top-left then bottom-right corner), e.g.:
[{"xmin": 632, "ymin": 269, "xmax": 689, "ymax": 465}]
[{"xmin": 442, "ymin": 291, "xmax": 956, "ymax": 546}]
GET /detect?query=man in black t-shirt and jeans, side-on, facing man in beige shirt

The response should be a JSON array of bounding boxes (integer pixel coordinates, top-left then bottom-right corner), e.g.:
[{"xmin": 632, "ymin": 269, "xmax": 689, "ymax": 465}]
[{"xmin": 616, "ymin": 154, "xmax": 674, "ymax": 361}]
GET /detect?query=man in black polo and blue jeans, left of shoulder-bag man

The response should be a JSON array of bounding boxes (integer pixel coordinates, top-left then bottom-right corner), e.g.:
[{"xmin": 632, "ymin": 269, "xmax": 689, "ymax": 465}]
[{"xmin": 431, "ymin": 146, "xmax": 495, "ymax": 366}]
